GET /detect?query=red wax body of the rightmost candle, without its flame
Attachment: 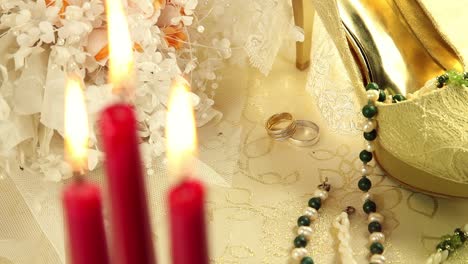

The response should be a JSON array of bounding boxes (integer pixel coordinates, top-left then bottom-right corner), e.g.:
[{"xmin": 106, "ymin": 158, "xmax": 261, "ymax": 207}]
[{"xmin": 169, "ymin": 179, "xmax": 209, "ymax": 264}]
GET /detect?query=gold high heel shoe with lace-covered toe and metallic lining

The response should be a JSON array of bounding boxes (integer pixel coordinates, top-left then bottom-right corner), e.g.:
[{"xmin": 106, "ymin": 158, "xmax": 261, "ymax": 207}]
[{"xmin": 296, "ymin": 0, "xmax": 468, "ymax": 197}]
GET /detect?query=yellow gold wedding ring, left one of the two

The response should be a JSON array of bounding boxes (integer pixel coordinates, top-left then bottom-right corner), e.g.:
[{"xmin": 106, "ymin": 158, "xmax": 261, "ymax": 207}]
[{"xmin": 265, "ymin": 113, "xmax": 296, "ymax": 141}]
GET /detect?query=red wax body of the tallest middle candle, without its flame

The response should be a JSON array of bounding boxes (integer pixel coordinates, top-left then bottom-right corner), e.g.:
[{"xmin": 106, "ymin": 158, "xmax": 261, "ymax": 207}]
[{"xmin": 100, "ymin": 104, "xmax": 156, "ymax": 264}]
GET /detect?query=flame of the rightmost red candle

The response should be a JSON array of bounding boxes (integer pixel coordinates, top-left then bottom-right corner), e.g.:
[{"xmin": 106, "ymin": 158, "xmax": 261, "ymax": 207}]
[{"xmin": 166, "ymin": 78, "xmax": 197, "ymax": 180}]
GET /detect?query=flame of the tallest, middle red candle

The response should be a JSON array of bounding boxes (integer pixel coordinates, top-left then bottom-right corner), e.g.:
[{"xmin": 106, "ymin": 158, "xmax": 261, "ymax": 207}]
[{"xmin": 106, "ymin": 0, "xmax": 133, "ymax": 93}]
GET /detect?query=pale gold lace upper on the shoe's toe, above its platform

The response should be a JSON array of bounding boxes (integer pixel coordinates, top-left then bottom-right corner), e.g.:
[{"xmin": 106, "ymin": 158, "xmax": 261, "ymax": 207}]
[{"xmin": 378, "ymin": 86, "xmax": 468, "ymax": 183}]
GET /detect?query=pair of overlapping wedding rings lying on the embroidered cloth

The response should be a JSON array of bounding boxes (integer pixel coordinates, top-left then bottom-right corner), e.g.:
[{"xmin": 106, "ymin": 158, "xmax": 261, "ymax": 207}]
[{"xmin": 265, "ymin": 112, "xmax": 320, "ymax": 147}]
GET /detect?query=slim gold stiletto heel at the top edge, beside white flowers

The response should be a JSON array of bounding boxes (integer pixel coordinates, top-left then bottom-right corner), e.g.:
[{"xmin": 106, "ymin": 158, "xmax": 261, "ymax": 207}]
[{"xmin": 292, "ymin": 0, "xmax": 315, "ymax": 71}]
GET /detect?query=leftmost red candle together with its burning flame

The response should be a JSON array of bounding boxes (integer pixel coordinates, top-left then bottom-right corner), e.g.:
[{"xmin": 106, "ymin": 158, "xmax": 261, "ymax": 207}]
[{"xmin": 63, "ymin": 76, "xmax": 109, "ymax": 264}]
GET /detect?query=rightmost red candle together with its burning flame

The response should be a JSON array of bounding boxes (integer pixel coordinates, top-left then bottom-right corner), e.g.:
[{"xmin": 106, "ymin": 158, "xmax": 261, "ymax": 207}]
[{"xmin": 166, "ymin": 79, "xmax": 209, "ymax": 264}]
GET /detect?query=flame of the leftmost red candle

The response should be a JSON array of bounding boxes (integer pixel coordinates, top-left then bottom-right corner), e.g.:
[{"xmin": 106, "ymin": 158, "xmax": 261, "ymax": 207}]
[{"xmin": 65, "ymin": 75, "xmax": 89, "ymax": 172}]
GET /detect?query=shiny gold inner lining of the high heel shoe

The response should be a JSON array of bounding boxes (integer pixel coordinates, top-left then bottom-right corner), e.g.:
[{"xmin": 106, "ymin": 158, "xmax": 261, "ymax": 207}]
[{"xmin": 338, "ymin": 0, "xmax": 461, "ymax": 94}]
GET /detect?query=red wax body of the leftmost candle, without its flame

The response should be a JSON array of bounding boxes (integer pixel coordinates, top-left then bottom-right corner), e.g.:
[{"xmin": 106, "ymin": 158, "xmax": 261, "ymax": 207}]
[{"xmin": 63, "ymin": 181, "xmax": 109, "ymax": 264}]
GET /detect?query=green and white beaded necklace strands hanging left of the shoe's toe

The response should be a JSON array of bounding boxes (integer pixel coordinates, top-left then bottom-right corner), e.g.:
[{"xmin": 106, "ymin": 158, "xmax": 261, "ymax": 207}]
[{"xmin": 291, "ymin": 83, "xmax": 386, "ymax": 264}]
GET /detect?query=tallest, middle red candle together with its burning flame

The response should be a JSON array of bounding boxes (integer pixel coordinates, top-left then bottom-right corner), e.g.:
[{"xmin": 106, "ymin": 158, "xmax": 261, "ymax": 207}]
[{"xmin": 99, "ymin": 0, "xmax": 156, "ymax": 264}]
